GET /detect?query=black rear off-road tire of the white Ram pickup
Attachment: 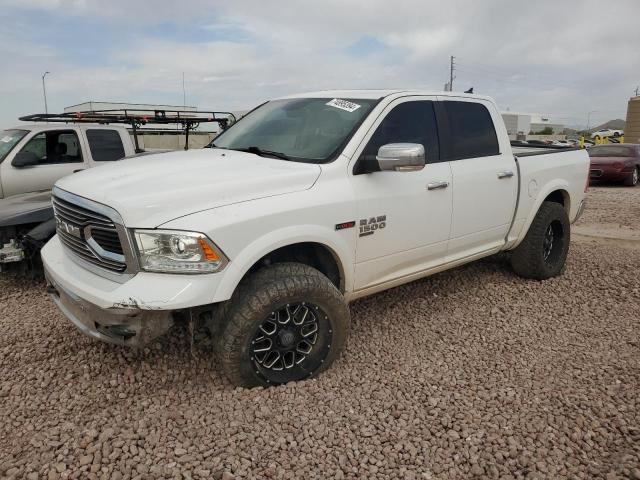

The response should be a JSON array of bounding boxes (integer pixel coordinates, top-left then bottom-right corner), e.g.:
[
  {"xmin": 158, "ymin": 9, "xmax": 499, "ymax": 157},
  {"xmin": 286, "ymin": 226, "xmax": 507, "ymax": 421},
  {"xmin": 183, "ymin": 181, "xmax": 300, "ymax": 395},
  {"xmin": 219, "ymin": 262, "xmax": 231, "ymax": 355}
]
[{"xmin": 511, "ymin": 202, "xmax": 571, "ymax": 280}]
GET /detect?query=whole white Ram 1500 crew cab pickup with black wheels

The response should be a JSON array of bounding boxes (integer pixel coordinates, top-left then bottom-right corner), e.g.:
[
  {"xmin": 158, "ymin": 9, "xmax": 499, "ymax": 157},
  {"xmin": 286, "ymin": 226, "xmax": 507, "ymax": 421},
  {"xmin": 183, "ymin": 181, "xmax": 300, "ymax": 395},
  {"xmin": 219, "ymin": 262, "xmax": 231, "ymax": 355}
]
[{"xmin": 42, "ymin": 90, "xmax": 589, "ymax": 386}]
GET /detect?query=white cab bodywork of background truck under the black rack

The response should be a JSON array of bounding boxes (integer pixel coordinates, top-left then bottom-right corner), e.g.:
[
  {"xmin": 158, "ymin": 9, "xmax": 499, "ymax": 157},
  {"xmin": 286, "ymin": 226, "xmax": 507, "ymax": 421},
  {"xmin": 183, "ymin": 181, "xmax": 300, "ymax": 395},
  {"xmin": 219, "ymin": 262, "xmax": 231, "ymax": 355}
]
[{"xmin": 0, "ymin": 123, "xmax": 135, "ymax": 198}]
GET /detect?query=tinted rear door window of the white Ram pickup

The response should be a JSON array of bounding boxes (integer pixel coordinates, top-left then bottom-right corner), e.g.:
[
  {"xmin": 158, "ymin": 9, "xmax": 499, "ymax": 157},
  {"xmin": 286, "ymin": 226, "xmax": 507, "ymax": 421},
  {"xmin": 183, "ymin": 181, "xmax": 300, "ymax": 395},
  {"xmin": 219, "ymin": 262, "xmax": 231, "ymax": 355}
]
[{"xmin": 442, "ymin": 101, "xmax": 500, "ymax": 160}]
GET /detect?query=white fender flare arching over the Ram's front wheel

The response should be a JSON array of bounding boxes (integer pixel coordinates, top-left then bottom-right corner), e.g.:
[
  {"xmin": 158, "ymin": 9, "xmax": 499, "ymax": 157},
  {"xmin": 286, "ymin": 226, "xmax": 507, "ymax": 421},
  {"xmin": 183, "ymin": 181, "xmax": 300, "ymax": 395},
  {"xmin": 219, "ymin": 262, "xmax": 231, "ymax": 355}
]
[{"xmin": 212, "ymin": 225, "xmax": 354, "ymax": 303}]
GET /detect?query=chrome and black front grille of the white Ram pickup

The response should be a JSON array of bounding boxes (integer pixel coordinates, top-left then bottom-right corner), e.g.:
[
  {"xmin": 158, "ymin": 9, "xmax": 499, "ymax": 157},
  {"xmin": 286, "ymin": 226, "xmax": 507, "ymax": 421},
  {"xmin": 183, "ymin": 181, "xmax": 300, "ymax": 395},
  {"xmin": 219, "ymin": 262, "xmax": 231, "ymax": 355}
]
[{"xmin": 51, "ymin": 196, "xmax": 127, "ymax": 273}]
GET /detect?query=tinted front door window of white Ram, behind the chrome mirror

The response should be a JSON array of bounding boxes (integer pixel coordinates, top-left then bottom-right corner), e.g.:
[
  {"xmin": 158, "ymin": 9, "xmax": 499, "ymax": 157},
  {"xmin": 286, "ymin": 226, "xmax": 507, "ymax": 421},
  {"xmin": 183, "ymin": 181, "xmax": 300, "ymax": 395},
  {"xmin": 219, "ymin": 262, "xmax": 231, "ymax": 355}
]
[{"xmin": 354, "ymin": 100, "xmax": 440, "ymax": 174}]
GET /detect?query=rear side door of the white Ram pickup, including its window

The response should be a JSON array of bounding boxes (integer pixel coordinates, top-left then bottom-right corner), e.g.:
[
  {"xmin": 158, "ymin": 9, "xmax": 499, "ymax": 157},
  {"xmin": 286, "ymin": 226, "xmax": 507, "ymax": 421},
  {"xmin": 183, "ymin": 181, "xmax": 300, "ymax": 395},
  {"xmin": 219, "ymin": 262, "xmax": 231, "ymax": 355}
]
[{"xmin": 438, "ymin": 97, "xmax": 518, "ymax": 261}]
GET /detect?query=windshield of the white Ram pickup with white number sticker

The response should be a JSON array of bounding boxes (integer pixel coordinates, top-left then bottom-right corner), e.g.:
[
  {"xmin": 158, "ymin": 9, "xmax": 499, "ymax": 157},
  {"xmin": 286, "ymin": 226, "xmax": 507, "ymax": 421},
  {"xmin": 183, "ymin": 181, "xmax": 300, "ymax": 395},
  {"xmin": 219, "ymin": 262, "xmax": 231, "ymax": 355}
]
[{"xmin": 211, "ymin": 98, "xmax": 377, "ymax": 163}]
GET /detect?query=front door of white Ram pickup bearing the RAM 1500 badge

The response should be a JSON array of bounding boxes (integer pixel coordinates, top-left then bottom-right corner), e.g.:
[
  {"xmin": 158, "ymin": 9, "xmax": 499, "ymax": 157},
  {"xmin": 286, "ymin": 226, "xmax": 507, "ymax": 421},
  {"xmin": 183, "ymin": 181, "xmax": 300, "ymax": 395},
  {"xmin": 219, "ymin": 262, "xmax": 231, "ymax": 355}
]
[{"xmin": 351, "ymin": 97, "xmax": 453, "ymax": 290}]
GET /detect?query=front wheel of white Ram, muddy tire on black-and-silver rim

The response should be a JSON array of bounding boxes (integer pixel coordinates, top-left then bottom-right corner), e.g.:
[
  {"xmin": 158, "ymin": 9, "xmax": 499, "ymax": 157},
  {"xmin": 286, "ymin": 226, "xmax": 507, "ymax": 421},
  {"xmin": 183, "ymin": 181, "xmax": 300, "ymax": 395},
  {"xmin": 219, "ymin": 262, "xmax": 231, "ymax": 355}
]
[{"xmin": 212, "ymin": 263, "xmax": 350, "ymax": 387}]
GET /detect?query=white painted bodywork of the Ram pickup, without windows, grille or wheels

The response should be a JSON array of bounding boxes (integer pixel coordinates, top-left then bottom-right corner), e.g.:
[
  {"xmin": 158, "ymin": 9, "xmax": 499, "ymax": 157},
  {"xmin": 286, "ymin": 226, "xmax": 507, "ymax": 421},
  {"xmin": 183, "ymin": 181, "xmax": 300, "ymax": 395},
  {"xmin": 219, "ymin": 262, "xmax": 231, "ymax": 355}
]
[{"xmin": 42, "ymin": 91, "xmax": 589, "ymax": 309}]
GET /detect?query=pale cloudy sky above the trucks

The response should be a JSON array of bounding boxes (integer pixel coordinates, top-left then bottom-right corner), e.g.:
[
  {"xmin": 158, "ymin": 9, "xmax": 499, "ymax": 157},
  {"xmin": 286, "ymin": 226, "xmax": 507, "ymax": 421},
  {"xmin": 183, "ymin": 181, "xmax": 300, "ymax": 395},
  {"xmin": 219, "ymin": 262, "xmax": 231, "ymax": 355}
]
[{"xmin": 0, "ymin": 0, "xmax": 640, "ymax": 128}]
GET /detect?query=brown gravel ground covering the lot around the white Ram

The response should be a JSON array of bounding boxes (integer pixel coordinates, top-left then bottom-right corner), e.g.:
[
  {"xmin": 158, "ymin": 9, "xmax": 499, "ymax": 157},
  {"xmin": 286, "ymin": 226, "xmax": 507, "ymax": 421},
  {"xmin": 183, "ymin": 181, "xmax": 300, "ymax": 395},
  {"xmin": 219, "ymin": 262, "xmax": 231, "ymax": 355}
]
[{"xmin": 0, "ymin": 188, "xmax": 640, "ymax": 480}]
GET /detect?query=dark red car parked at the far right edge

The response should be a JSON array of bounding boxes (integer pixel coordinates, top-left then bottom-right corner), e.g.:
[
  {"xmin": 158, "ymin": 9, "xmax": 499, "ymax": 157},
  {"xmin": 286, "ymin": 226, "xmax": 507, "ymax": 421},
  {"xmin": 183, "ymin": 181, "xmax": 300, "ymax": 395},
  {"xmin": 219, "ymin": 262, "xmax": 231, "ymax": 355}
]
[{"xmin": 588, "ymin": 143, "xmax": 640, "ymax": 187}]
